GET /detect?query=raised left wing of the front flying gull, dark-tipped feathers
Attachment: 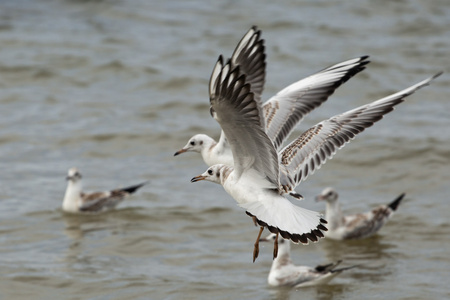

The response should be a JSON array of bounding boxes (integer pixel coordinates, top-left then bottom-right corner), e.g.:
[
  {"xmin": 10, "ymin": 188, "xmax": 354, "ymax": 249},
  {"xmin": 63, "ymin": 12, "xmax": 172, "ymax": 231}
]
[{"xmin": 209, "ymin": 56, "xmax": 279, "ymax": 187}]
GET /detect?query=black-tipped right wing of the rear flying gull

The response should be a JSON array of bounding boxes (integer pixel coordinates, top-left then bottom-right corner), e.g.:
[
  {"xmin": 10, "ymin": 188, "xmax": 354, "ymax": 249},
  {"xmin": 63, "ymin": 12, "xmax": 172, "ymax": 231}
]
[{"xmin": 264, "ymin": 56, "xmax": 370, "ymax": 150}]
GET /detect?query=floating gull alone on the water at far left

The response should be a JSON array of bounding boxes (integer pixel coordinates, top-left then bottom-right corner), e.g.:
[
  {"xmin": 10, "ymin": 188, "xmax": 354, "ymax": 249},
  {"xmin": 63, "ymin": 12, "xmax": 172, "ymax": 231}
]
[{"xmin": 62, "ymin": 168, "xmax": 147, "ymax": 213}]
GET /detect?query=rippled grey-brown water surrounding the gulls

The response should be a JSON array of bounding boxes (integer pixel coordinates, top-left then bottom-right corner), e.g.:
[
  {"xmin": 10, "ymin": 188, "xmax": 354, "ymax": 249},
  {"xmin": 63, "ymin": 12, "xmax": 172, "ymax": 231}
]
[{"xmin": 0, "ymin": 0, "xmax": 450, "ymax": 299}]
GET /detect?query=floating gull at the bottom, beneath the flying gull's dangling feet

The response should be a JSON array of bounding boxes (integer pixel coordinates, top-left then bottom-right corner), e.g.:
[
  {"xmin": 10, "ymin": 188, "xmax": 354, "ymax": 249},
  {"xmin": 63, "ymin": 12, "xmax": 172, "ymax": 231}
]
[{"xmin": 260, "ymin": 233, "xmax": 356, "ymax": 288}]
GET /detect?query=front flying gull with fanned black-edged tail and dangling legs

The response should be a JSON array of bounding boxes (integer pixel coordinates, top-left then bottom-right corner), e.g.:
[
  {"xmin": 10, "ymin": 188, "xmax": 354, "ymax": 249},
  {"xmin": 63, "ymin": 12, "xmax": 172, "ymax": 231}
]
[{"xmin": 191, "ymin": 49, "xmax": 441, "ymax": 261}]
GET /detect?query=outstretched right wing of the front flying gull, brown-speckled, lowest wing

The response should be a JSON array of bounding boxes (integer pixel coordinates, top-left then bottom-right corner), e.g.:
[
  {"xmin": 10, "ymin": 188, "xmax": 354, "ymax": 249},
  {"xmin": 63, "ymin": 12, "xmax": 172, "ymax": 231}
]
[{"xmin": 280, "ymin": 73, "xmax": 441, "ymax": 190}]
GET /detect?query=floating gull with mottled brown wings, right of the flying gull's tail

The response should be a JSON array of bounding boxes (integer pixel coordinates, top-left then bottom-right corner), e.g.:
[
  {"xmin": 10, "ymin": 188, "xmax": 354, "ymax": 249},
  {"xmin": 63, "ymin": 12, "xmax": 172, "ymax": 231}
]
[{"xmin": 316, "ymin": 188, "xmax": 405, "ymax": 240}]
